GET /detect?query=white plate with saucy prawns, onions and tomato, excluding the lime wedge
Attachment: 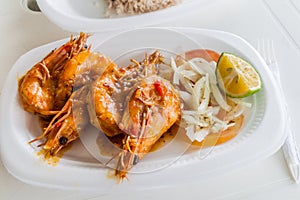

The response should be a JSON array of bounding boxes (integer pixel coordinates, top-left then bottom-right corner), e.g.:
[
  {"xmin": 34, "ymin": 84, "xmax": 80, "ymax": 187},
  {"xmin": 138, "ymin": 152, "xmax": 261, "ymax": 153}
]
[{"xmin": 0, "ymin": 28, "xmax": 285, "ymax": 192}]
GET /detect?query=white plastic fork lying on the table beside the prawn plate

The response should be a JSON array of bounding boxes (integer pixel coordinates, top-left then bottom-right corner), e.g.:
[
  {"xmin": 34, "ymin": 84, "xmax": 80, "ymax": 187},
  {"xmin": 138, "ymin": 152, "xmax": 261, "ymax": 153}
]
[{"xmin": 257, "ymin": 40, "xmax": 300, "ymax": 183}]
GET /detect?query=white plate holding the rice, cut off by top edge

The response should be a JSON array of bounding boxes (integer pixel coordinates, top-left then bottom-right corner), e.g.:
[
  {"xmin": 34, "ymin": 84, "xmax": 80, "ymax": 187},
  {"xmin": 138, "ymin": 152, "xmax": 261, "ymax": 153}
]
[{"xmin": 37, "ymin": 0, "xmax": 216, "ymax": 32}]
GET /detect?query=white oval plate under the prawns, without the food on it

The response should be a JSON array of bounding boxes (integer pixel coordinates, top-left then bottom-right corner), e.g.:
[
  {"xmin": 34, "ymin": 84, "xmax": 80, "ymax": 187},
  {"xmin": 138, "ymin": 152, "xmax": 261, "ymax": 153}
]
[{"xmin": 0, "ymin": 28, "xmax": 286, "ymax": 193}]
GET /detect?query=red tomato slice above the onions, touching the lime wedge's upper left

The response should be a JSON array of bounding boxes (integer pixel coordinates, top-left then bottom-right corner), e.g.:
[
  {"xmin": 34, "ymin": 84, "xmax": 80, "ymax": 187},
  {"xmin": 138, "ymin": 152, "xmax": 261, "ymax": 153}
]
[{"xmin": 185, "ymin": 49, "xmax": 220, "ymax": 62}]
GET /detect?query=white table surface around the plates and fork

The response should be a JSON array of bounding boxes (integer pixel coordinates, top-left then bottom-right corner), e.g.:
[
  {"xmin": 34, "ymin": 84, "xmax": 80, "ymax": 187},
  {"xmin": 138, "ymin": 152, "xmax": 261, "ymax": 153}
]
[{"xmin": 0, "ymin": 0, "xmax": 300, "ymax": 200}]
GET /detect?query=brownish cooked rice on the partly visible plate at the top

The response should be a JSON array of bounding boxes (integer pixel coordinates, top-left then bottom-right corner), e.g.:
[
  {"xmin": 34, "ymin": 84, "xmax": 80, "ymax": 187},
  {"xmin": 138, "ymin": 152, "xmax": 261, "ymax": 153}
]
[{"xmin": 105, "ymin": 0, "xmax": 181, "ymax": 16}]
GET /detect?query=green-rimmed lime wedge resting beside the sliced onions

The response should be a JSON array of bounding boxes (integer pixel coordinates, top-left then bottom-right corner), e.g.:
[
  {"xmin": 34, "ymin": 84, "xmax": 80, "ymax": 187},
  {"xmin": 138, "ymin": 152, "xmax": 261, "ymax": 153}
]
[{"xmin": 216, "ymin": 52, "xmax": 262, "ymax": 98}]
